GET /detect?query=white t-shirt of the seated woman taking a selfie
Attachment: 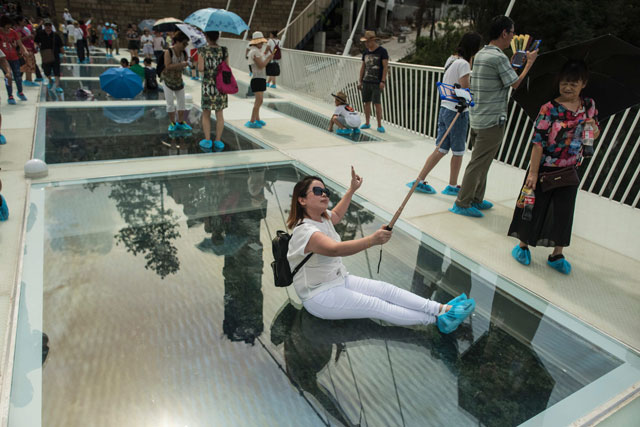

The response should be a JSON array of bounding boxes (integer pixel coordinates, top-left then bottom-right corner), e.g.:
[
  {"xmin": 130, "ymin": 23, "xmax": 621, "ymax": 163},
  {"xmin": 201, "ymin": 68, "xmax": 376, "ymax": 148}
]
[{"xmin": 287, "ymin": 210, "xmax": 349, "ymax": 301}]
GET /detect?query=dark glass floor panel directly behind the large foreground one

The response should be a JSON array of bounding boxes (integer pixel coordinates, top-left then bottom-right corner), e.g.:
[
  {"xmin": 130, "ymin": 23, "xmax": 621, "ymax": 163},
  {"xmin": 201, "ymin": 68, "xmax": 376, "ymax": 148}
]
[{"xmin": 34, "ymin": 105, "xmax": 268, "ymax": 164}]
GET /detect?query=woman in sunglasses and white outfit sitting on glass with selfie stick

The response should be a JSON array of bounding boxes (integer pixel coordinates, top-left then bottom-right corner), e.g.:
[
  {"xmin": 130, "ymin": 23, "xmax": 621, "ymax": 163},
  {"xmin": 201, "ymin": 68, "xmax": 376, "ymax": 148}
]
[{"xmin": 287, "ymin": 167, "xmax": 475, "ymax": 333}]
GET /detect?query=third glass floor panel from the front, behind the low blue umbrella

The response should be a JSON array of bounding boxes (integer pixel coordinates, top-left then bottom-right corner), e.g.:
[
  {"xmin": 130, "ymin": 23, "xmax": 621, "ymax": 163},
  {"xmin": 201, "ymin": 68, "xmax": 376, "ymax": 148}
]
[{"xmin": 40, "ymin": 78, "xmax": 164, "ymax": 102}]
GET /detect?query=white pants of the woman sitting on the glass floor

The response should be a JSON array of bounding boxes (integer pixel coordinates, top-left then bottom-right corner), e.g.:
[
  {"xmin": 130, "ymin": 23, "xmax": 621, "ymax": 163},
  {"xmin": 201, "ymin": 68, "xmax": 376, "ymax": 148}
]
[{"xmin": 303, "ymin": 275, "xmax": 440, "ymax": 326}]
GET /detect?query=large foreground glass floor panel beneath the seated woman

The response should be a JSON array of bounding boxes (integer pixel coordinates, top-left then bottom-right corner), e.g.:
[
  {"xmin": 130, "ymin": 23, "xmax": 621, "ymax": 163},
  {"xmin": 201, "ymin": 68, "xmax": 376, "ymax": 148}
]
[{"xmin": 9, "ymin": 165, "xmax": 640, "ymax": 427}]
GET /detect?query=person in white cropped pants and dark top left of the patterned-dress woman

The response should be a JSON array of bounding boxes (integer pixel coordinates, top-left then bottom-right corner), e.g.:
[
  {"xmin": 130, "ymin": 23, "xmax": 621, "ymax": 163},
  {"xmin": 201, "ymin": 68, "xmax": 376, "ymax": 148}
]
[{"xmin": 162, "ymin": 31, "xmax": 192, "ymax": 132}]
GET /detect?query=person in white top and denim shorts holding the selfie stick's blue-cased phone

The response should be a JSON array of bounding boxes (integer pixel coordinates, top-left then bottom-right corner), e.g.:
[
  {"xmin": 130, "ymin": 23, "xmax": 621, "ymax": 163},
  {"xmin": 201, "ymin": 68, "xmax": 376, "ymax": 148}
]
[{"xmin": 407, "ymin": 32, "xmax": 482, "ymax": 196}]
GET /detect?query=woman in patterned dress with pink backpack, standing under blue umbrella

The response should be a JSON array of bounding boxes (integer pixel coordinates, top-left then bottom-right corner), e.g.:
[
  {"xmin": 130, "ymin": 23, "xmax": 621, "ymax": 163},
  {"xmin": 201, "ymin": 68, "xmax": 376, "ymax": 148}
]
[{"xmin": 198, "ymin": 31, "xmax": 229, "ymax": 151}]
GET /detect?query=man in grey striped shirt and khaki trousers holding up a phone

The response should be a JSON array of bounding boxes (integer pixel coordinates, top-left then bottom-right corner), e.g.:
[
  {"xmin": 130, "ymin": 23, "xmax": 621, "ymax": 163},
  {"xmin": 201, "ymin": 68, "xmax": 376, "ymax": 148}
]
[{"xmin": 449, "ymin": 15, "xmax": 538, "ymax": 217}]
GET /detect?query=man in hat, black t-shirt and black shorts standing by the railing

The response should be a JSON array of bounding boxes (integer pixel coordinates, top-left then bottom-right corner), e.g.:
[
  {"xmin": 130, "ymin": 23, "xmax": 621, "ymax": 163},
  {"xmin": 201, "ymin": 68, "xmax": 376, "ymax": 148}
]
[{"xmin": 358, "ymin": 31, "xmax": 389, "ymax": 133}]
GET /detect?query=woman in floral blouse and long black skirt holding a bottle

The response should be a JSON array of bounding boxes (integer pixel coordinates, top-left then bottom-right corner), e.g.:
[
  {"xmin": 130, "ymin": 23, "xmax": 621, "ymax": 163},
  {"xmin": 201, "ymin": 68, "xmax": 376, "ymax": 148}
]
[{"xmin": 509, "ymin": 60, "xmax": 600, "ymax": 274}]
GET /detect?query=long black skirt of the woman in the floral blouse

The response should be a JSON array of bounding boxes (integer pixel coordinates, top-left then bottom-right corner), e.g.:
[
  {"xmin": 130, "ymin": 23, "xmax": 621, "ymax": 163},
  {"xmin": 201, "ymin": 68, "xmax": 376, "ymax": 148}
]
[{"xmin": 509, "ymin": 166, "xmax": 579, "ymax": 247}]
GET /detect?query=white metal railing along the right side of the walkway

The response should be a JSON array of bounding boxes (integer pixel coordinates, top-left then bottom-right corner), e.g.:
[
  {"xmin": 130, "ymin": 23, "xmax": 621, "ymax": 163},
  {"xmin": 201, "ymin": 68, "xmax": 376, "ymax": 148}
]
[{"xmin": 223, "ymin": 39, "xmax": 640, "ymax": 208}]
